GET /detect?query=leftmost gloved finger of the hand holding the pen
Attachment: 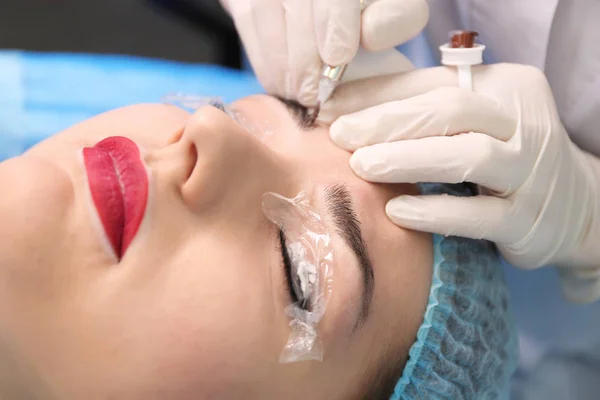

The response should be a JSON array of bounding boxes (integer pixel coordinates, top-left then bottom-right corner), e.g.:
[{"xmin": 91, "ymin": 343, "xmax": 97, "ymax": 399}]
[{"xmin": 228, "ymin": 0, "xmax": 288, "ymax": 95}]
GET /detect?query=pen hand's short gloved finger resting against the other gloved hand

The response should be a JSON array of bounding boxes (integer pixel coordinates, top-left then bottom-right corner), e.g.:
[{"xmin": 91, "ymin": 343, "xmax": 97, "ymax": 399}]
[{"xmin": 342, "ymin": 47, "xmax": 415, "ymax": 82}]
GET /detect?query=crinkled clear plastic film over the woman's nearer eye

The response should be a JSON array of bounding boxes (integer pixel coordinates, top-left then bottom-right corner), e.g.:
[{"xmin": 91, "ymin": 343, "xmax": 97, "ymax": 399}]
[{"xmin": 262, "ymin": 192, "xmax": 333, "ymax": 363}]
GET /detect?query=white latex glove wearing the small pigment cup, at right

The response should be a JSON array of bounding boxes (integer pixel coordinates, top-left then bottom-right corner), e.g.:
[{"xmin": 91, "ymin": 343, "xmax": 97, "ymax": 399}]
[{"xmin": 321, "ymin": 64, "xmax": 600, "ymax": 301}]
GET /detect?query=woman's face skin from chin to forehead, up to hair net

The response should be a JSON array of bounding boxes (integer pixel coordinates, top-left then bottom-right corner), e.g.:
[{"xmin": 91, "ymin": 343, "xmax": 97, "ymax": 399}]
[{"xmin": 0, "ymin": 96, "xmax": 432, "ymax": 400}]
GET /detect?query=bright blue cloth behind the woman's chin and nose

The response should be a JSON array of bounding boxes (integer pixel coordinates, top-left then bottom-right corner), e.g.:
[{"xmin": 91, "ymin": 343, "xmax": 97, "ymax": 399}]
[{"xmin": 0, "ymin": 51, "xmax": 262, "ymax": 160}]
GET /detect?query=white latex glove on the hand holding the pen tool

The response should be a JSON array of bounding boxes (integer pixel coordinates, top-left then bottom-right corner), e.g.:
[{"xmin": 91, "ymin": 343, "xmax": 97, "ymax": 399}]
[{"xmin": 220, "ymin": 0, "xmax": 429, "ymax": 106}]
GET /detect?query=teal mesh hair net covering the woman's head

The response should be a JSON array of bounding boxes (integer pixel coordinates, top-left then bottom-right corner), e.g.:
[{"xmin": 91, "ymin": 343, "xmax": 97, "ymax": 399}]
[{"xmin": 391, "ymin": 184, "xmax": 518, "ymax": 400}]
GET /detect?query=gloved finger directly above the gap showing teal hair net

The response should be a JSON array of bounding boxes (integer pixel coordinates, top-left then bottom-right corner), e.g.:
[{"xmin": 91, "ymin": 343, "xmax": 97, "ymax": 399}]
[{"xmin": 350, "ymin": 133, "xmax": 522, "ymax": 193}]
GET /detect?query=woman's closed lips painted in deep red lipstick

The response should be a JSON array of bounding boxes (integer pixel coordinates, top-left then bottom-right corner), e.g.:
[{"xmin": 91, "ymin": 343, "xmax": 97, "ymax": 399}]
[{"xmin": 83, "ymin": 136, "xmax": 148, "ymax": 259}]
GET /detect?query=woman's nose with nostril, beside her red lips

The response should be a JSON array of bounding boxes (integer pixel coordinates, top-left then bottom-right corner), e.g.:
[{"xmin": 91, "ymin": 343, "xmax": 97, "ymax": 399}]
[{"xmin": 181, "ymin": 107, "xmax": 285, "ymax": 215}]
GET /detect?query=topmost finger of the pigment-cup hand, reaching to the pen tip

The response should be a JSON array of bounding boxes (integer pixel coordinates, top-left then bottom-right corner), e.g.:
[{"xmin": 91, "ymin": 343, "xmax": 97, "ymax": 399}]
[{"xmin": 319, "ymin": 67, "xmax": 458, "ymax": 124}]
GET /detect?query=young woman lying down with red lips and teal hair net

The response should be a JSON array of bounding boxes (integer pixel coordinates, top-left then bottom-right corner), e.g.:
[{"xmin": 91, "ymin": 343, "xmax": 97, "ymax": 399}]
[{"xmin": 0, "ymin": 95, "xmax": 515, "ymax": 400}]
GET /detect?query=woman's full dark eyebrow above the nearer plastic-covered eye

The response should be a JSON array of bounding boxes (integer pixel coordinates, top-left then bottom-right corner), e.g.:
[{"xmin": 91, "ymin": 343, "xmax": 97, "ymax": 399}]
[{"xmin": 325, "ymin": 184, "xmax": 375, "ymax": 330}]
